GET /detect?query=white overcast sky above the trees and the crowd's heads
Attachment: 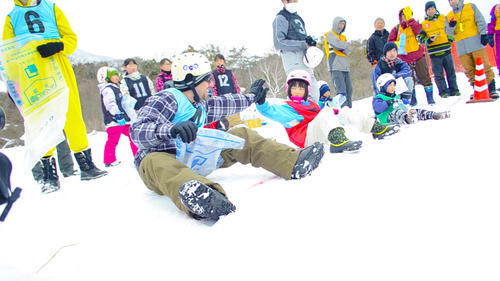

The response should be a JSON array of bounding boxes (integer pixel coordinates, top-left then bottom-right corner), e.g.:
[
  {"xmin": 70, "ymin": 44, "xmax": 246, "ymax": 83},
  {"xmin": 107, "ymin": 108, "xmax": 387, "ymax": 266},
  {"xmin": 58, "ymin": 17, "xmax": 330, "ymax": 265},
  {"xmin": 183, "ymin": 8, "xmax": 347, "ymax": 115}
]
[{"xmin": 0, "ymin": 0, "xmax": 495, "ymax": 59}]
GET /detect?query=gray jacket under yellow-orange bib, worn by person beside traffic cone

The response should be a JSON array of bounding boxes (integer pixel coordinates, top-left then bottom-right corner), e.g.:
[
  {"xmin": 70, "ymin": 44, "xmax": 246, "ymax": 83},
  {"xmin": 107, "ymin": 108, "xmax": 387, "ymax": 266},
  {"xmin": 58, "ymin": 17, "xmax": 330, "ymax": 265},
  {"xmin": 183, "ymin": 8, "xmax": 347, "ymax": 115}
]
[{"xmin": 446, "ymin": 0, "xmax": 488, "ymax": 56}]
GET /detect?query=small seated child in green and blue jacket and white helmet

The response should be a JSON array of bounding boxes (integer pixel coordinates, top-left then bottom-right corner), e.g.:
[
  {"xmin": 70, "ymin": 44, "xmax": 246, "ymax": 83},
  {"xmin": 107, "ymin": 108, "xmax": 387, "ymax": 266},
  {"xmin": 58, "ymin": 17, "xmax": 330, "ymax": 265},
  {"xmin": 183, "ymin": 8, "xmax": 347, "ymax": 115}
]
[{"xmin": 372, "ymin": 73, "xmax": 450, "ymax": 125}]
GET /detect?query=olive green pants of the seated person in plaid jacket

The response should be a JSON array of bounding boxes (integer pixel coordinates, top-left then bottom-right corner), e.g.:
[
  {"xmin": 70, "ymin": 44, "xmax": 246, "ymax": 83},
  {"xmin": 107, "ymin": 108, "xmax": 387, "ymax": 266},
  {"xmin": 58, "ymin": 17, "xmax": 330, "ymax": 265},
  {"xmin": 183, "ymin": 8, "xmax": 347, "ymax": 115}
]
[{"xmin": 139, "ymin": 127, "xmax": 300, "ymax": 214}]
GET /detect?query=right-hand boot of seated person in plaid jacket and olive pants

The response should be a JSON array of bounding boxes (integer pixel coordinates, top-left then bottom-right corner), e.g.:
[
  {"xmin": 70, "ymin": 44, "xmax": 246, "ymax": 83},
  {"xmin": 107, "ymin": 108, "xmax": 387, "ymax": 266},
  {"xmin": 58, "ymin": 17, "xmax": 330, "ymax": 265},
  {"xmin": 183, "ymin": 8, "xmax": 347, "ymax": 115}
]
[{"xmin": 290, "ymin": 142, "xmax": 325, "ymax": 180}]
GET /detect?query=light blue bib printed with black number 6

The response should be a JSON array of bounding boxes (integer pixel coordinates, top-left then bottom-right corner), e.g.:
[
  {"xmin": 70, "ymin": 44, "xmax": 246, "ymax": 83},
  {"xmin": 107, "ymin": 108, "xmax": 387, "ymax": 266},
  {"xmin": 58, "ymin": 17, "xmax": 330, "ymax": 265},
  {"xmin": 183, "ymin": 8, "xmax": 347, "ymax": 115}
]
[{"xmin": 9, "ymin": 0, "xmax": 61, "ymax": 39}]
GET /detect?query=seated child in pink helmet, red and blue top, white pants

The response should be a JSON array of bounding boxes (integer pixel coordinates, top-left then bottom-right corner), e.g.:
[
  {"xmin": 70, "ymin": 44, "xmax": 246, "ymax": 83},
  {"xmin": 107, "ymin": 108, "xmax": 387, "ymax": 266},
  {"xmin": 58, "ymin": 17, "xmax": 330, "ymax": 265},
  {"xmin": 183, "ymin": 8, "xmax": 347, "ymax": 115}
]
[{"xmin": 257, "ymin": 70, "xmax": 362, "ymax": 153}]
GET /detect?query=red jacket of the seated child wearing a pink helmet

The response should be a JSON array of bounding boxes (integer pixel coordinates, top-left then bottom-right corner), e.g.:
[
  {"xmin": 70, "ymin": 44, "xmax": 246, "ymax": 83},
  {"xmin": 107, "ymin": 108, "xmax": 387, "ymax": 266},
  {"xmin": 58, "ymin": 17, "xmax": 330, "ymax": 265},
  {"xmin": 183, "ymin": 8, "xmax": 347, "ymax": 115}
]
[{"xmin": 285, "ymin": 100, "xmax": 321, "ymax": 148}]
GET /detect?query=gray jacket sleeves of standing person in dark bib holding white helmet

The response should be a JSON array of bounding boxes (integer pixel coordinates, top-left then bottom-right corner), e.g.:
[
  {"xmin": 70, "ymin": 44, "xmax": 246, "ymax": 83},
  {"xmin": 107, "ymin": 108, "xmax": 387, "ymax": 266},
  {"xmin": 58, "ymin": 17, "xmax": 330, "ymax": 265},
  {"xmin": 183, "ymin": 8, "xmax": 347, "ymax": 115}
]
[{"xmin": 273, "ymin": 10, "xmax": 307, "ymax": 52}]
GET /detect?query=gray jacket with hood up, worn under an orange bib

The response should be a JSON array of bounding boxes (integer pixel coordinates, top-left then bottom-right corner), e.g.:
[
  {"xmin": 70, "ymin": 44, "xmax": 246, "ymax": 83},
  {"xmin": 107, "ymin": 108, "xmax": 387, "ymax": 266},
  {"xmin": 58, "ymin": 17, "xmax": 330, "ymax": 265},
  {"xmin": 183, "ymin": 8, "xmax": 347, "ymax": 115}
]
[{"xmin": 326, "ymin": 17, "xmax": 351, "ymax": 72}]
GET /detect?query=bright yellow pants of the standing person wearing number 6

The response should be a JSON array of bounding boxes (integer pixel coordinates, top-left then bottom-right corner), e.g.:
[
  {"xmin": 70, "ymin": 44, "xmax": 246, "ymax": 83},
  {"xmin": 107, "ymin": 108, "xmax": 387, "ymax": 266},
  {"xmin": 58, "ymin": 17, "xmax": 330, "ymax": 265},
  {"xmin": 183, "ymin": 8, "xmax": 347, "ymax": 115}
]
[{"xmin": 45, "ymin": 53, "xmax": 89, "ymax": 156}]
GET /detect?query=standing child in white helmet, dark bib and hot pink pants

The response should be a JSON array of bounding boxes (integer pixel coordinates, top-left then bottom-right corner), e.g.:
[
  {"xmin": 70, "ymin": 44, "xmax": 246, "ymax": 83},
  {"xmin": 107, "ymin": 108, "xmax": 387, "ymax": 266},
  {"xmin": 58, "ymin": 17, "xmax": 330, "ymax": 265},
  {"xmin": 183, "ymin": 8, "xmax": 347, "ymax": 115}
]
[{"xmin": 97, "ymin": 66, "xmax": 137, "ymax": 167}]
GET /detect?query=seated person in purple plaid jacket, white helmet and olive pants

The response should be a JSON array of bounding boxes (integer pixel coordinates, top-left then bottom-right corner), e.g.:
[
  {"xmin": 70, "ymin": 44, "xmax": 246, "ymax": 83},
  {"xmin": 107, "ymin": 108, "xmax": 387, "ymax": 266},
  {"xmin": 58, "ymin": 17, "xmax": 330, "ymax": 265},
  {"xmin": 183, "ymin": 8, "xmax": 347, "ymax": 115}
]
[{"xmin": 130, "ymin": 52, "xmax": 324, "ymax": 220}]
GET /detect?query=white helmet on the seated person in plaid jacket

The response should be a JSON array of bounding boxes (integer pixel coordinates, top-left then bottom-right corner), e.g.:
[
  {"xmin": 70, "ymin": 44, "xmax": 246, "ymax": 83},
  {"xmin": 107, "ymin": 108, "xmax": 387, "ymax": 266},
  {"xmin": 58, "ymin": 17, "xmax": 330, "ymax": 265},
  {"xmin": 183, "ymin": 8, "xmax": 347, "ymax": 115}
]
[{"xmin": 172, "ymin": 52, "xmax": 212, "ymax": 91}]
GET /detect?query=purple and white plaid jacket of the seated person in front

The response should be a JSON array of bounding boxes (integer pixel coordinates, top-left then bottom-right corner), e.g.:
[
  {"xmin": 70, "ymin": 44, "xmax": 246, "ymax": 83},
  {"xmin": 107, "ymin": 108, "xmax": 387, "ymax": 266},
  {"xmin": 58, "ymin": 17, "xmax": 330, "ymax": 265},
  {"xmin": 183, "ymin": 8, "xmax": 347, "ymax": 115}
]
[{"xmin": 130, "ymin": 88, "xmax": 255, "ymax": 166}]
